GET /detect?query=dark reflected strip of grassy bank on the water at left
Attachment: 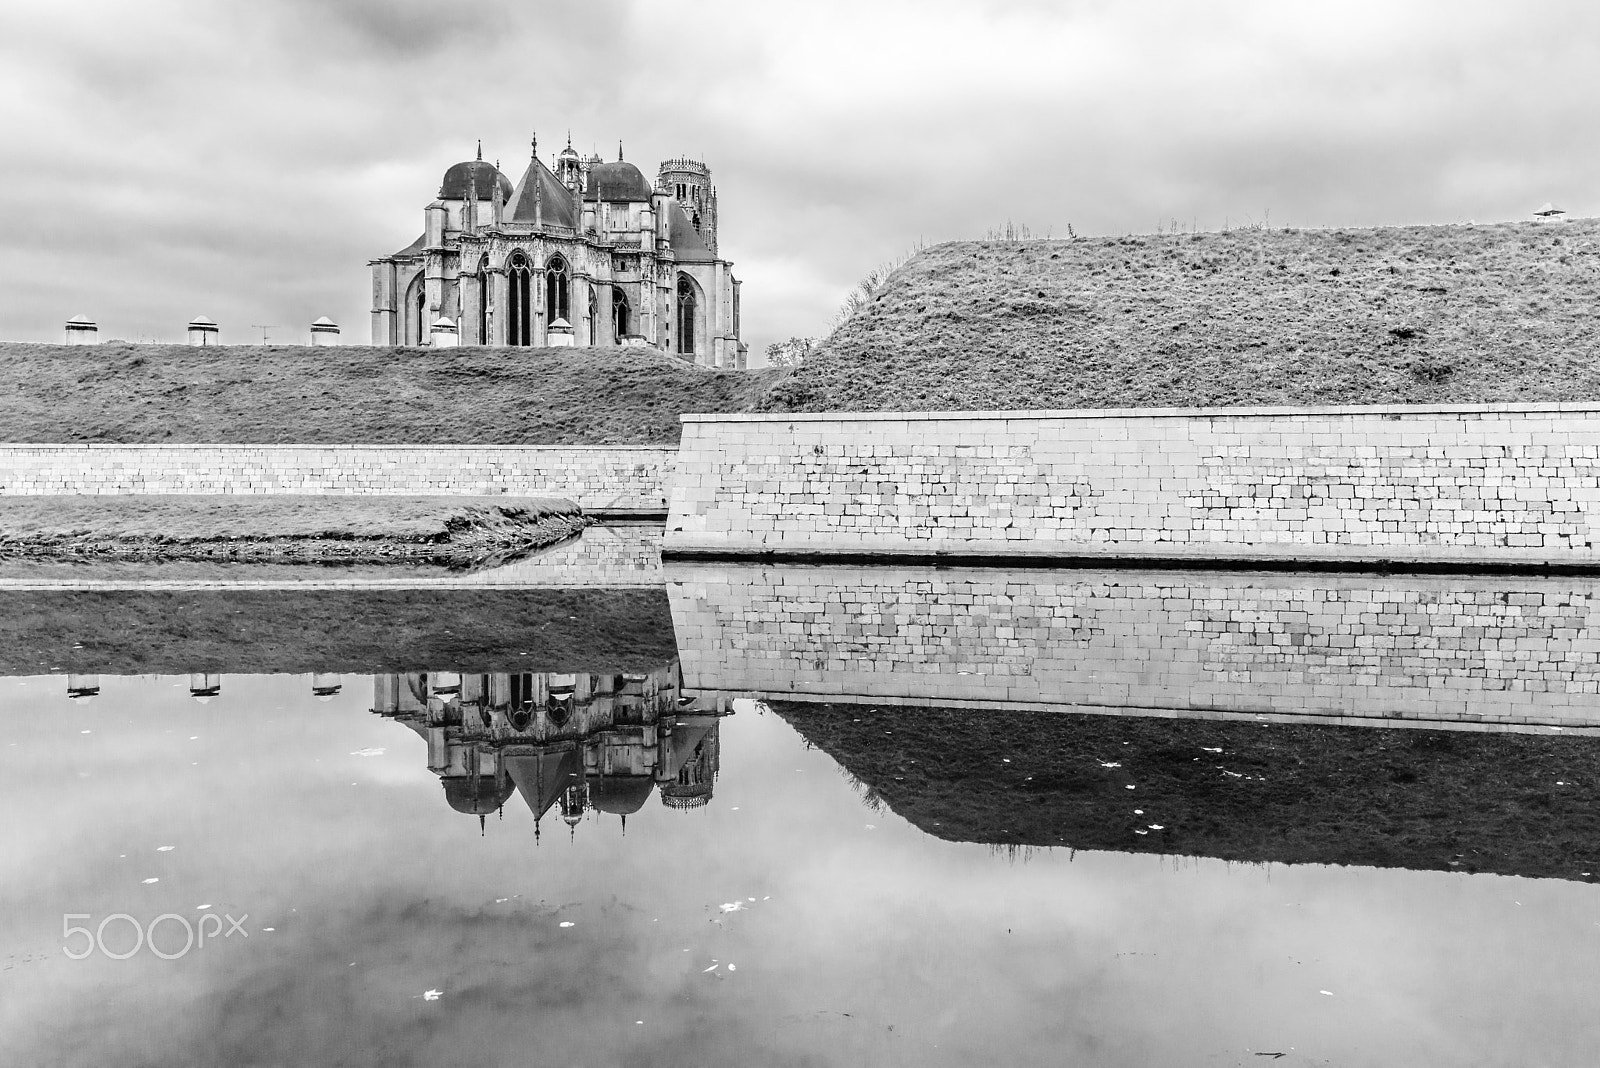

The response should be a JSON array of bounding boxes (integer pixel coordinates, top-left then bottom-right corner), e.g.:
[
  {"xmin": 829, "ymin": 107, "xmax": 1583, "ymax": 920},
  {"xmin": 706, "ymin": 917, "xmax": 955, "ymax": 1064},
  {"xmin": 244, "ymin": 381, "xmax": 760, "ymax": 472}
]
[{"xmin": 0, "ymin": 590, "xmax": 677, "ymax": 675}]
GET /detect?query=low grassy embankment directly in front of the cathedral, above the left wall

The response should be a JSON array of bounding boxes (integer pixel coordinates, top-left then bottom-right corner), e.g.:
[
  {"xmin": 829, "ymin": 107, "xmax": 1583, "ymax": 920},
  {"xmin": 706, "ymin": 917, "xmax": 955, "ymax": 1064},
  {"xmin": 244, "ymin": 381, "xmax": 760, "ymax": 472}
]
[{"xmin": 0, "ymin": 342, "xmax": 779, "ymax": 444}]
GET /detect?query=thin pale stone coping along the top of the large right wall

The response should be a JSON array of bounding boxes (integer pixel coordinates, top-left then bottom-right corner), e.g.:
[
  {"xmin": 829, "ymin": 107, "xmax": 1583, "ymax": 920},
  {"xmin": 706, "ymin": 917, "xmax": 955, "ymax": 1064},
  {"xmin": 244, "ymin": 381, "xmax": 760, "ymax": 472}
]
[{"xmin": 678, "ymin": 401, "xmax": 1600, "ymax": 424}]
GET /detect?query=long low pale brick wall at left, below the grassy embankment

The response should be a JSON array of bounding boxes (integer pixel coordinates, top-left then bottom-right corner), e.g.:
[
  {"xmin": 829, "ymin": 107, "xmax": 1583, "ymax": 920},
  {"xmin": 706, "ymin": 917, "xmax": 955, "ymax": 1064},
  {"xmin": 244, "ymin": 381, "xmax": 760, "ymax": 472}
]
[{"xmin": 0, "ymin": 444, "xmax": 677, "ymax": 512}]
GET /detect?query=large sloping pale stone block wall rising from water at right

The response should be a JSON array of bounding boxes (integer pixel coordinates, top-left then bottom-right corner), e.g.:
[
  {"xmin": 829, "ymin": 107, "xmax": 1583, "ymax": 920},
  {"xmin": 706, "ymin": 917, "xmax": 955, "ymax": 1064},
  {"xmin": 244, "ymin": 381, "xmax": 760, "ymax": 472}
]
[{"xmin": 666, "ymin": 404, "xmax": 1600, "ymax": 563}]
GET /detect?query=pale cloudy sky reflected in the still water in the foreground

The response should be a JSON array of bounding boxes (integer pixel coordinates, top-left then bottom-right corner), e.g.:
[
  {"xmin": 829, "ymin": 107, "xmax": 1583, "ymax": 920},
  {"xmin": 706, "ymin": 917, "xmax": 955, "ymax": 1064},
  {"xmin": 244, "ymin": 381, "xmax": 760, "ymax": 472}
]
[{"xmin": 0, "ymin": 676, "xmax": 1595, "ymax": 1066}]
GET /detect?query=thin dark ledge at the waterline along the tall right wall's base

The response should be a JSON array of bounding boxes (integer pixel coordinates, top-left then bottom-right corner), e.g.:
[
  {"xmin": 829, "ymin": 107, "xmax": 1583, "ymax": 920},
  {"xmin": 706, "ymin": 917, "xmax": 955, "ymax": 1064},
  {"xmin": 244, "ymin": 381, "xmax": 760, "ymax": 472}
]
[{"xmin": 661, "ymin": 542, "xmax": 1600, "ymax": 576}]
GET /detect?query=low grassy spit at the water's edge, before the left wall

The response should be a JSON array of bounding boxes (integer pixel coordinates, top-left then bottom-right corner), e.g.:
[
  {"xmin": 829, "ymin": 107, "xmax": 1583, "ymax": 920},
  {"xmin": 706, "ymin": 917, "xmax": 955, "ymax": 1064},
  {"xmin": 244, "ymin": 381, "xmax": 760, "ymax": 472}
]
[{"xmin": 0, "ymin": 494, "xmax": 587, "ymax": 568}]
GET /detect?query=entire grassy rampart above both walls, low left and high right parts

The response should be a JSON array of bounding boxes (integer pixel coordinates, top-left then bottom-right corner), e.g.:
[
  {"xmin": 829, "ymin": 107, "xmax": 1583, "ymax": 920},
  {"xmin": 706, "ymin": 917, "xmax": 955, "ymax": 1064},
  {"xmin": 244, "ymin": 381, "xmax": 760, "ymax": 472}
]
[{"xmin": 12, "ymin": 219, "xmax": 1600, "ymax": 444}]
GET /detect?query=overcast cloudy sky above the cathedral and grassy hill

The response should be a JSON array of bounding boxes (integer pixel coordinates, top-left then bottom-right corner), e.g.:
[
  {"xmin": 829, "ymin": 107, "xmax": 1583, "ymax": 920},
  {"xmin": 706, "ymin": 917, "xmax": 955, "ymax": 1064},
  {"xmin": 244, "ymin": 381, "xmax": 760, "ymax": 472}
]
[{"xmin": 0, "ymin": 0, "xmax": 1600, "ymax": 361}]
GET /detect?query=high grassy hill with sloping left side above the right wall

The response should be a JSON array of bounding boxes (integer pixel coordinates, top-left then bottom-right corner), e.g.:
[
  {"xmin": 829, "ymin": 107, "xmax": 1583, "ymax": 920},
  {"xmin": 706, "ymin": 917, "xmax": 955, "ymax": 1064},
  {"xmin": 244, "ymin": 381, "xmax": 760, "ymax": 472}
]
[{"xmin": 763, "ymin": 219, "xmax": 1600, "ymax": 411}]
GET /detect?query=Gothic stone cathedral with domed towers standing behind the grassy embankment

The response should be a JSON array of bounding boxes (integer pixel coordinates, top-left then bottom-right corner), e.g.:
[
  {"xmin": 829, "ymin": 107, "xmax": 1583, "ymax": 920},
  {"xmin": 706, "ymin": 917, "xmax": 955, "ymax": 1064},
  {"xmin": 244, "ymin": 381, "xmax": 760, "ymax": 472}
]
[{"xmin": 371, "ymin": 137, "xmax": 747, "ymax": 368}]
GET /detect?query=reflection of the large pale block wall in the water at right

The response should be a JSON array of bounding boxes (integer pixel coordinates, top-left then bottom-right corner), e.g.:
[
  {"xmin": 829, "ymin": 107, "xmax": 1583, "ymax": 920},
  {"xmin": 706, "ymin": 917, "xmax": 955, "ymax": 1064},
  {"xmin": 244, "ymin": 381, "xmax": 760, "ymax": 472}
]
[{"xmin": 667, "ymin": 563, "xmax": 1600, "ymax": 726}]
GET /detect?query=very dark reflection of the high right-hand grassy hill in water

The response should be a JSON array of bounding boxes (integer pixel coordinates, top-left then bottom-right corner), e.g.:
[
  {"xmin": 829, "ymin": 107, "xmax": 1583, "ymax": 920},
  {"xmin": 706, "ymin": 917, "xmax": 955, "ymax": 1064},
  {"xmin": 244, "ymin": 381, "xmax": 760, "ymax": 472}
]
[{"xmin": 771, "ymin": 702, "xmax": 1600, "ymax": 879}]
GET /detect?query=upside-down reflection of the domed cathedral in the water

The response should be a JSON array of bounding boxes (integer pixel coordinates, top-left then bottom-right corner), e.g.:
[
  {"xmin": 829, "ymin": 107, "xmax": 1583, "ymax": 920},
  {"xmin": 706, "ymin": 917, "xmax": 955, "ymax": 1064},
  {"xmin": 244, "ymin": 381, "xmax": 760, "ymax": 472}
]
[{"xmin": 373, "ymin": 660, "xmax": 723, "ymax": 827}]
